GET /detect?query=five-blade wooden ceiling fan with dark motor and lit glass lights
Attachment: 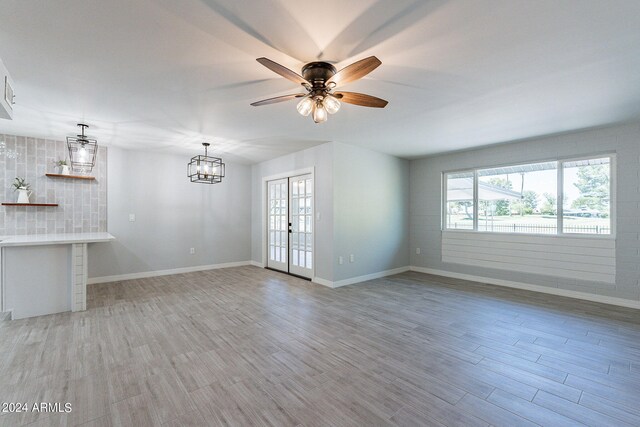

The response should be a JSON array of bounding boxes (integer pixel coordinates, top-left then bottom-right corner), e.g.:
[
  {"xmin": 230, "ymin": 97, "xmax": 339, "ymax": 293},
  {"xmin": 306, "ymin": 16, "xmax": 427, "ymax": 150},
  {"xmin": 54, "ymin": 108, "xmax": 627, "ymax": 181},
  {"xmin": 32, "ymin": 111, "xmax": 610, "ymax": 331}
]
[{"xmin": 251, "ymin": 56, "xmax": 388, "ymax": 123}]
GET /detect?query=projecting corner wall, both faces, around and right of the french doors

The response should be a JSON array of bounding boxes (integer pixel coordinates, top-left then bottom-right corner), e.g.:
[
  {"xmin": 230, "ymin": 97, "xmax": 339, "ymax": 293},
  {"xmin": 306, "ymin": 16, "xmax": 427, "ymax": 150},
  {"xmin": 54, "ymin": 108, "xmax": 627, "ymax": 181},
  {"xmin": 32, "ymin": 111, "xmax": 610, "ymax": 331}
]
[{"xmin": 251, "ymin": 142, "xmax": 409, "ymax": 285}]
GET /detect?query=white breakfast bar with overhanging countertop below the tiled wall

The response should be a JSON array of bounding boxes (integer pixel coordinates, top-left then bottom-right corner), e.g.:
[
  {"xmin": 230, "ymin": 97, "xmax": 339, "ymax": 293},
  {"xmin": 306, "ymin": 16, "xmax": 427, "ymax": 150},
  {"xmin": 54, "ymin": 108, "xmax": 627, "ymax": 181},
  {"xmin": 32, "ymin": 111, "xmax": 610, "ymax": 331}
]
[{"xmin": 0, "ymin": 232, "xmax": 114, "ymax": 319}]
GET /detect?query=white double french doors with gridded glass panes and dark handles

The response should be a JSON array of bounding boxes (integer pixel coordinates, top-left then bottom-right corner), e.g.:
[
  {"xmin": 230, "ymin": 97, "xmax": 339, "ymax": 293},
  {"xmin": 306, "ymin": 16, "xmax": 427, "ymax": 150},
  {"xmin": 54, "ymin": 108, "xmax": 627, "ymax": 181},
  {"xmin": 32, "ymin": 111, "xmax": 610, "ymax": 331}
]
[{"xmin": 267, "ymin": 174, "xmax": 313, "ymax": 279}]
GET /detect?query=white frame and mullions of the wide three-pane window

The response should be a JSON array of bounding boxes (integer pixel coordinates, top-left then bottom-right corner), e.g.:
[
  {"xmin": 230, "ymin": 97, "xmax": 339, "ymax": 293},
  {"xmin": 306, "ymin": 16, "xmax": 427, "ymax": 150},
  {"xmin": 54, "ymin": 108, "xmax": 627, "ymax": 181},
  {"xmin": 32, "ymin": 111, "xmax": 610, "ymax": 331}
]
[{"xmin": 440, "ymin": 152, "xmax": 617, "ymax": 239}]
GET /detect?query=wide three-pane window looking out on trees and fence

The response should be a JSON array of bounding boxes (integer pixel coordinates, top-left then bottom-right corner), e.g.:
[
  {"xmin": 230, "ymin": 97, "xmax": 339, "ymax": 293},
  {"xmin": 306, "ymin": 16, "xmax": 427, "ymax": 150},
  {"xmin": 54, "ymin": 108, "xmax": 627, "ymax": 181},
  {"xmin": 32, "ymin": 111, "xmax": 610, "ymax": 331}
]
[{"xmin": 444, "ymin": 156, "xmax": 612, "ymax": 235}]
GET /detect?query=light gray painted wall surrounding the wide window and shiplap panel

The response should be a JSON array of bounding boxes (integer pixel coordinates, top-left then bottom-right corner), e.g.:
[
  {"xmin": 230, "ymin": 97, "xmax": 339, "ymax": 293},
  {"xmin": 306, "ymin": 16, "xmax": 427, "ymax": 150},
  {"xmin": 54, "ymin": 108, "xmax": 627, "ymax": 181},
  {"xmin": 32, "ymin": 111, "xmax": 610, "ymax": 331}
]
[{"xmin": 410, "ymin": 123, "xmax": 640, "ymax": 301}]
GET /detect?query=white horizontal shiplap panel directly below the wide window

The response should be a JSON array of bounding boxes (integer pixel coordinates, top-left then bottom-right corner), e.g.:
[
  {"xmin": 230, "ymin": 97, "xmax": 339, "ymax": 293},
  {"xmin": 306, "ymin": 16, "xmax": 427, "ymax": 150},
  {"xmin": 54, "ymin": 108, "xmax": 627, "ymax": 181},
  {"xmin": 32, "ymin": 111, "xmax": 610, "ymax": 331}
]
[{"xmin": 442, "ymin": 231, "xmax": 616, "ymax": 283}]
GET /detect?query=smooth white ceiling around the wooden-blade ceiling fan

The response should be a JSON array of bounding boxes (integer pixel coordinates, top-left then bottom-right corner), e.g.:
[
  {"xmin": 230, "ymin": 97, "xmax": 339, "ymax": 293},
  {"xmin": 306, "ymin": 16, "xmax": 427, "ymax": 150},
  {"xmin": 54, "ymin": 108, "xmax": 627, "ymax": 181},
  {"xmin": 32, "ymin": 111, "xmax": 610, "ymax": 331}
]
[{"xmin": 0, "ymin": 0, "xmax": 640, "ymax": 163}]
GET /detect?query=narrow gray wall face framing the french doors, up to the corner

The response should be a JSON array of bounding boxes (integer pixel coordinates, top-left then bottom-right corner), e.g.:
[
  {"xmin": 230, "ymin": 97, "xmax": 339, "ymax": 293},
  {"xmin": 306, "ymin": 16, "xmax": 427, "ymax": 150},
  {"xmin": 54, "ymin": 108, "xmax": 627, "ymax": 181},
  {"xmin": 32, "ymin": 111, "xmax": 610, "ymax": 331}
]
[{"xmin": 251, "ymin": 143, "xmax": 333, "ymax": 280}]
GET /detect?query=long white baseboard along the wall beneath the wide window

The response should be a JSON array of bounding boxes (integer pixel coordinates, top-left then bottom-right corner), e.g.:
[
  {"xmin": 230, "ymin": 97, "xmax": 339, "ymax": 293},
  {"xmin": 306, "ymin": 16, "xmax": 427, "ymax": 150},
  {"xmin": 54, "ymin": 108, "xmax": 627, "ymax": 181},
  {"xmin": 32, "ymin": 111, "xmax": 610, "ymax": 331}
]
[{"xmin": 409, "ymin": 266, "xmax": 640, "ymax": 309}]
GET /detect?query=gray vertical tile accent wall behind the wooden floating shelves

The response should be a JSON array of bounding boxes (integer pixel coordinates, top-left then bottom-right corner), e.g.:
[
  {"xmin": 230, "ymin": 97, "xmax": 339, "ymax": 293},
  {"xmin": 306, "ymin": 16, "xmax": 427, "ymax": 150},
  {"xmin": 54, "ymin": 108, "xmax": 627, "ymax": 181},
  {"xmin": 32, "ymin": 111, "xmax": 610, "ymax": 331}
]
[{"xmin": 0, "ymin": 134, "xmax": 107, "ymax": 236}]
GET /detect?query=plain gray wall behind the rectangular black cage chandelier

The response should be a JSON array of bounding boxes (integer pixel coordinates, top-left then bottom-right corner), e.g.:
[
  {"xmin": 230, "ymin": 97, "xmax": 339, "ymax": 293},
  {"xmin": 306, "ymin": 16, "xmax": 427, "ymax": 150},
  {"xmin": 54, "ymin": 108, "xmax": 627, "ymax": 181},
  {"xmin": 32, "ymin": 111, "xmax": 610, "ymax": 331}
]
[{"xmin": 89, "ymin": 147, "xmax": 251, "ymax": 278}]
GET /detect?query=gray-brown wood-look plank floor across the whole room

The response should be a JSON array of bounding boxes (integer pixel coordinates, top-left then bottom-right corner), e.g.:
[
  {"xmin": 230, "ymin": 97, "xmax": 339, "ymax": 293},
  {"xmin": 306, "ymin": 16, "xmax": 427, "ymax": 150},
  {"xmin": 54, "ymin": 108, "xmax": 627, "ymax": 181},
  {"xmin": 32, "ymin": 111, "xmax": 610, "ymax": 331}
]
[{"xmin": 0, "ymin": 267, "xmax": 640, "ymax": 427}]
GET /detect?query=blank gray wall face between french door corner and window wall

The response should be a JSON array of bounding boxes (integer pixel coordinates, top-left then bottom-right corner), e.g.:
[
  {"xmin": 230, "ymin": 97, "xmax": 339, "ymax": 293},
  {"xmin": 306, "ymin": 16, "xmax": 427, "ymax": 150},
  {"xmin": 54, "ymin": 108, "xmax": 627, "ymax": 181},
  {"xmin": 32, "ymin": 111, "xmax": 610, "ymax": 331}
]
[{"xmin": 333, "ymin": 143, "xmax": 409, "ymax": 281}]
